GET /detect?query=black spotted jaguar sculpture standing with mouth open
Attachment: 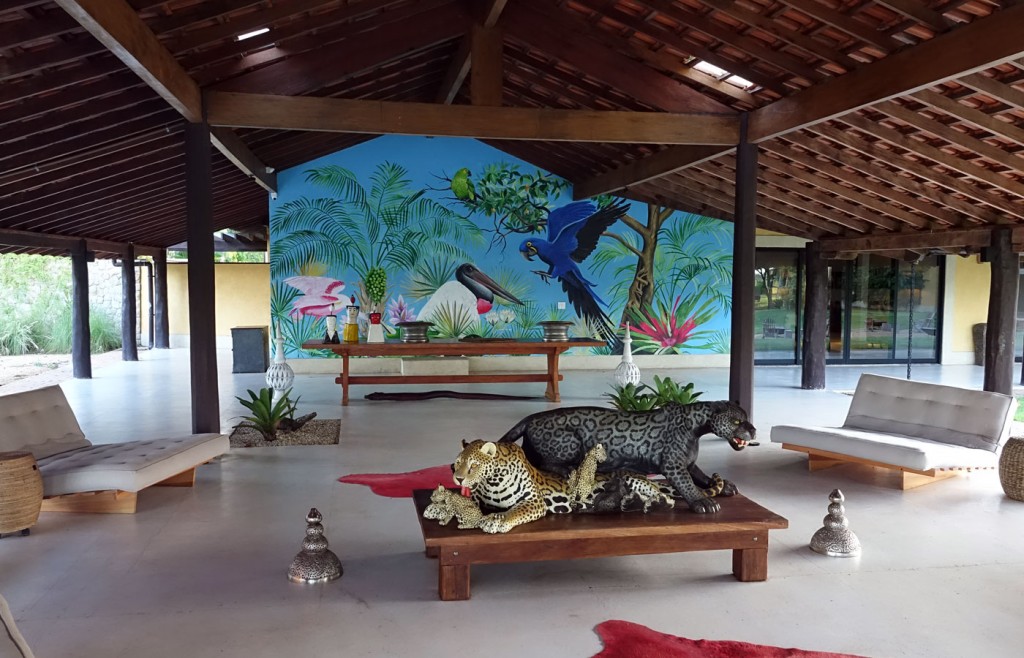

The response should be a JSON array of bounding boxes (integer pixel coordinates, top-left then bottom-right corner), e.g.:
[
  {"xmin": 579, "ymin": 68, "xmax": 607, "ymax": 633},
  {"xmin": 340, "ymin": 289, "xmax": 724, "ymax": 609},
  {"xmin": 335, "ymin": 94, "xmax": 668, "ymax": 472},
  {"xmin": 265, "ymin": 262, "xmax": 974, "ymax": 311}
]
[{"xmin": 499, "ymin": 401, "xmax": 757, "ymax": 514}]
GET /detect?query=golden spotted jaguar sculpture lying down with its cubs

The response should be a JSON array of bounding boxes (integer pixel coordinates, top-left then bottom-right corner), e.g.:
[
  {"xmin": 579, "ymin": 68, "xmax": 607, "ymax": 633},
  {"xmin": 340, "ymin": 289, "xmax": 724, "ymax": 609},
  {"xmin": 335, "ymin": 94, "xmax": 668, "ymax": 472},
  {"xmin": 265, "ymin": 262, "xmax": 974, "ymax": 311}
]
[{"xmin": 442, "ymin": 440, "xmax": 723, "ymax": 533}]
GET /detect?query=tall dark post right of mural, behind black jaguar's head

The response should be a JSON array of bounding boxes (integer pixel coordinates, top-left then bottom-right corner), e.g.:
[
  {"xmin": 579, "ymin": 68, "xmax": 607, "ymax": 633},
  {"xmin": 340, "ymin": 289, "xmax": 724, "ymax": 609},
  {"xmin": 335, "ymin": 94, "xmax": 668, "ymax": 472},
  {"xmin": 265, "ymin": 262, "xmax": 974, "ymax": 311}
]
[{"xmin": 729, "ymin": 114, "xmax": 758, "ymax": 416}]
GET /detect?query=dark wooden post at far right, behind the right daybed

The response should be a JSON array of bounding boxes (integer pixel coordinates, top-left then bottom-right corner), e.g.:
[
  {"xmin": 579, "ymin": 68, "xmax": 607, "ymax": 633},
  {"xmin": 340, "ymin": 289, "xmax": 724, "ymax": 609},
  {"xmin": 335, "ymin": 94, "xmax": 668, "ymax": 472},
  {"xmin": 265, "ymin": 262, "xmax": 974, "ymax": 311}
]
[{"xmin": 985, "ymin": 228, "xmax": 1020, "ymax": 395}]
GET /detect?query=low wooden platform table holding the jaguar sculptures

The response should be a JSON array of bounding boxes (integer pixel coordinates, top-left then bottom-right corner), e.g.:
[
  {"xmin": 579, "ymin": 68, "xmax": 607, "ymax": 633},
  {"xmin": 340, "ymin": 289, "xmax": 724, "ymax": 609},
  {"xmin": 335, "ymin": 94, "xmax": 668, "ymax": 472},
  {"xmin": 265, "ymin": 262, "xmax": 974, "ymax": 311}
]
[{"xmin": 413, "ymin": 489, "xmax": 790, "ymax": 601}]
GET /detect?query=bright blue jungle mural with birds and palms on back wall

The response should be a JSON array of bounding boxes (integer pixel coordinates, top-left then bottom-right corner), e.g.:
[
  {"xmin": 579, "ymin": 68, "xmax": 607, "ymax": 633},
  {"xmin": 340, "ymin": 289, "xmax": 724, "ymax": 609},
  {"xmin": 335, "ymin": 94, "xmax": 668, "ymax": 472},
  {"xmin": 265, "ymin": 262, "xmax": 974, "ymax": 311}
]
[{"xmin": 270, "ymin": 136, "xmax": 732, "ymax": 358}]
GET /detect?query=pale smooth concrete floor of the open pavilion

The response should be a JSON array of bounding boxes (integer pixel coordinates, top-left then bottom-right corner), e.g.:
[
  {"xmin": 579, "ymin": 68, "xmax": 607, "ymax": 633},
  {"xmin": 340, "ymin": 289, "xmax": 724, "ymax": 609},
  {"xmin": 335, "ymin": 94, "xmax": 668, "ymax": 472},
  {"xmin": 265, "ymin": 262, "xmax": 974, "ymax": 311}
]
[{"xmin": 0, "ymin": 350, "xmax": 1024, "ymax": 658}]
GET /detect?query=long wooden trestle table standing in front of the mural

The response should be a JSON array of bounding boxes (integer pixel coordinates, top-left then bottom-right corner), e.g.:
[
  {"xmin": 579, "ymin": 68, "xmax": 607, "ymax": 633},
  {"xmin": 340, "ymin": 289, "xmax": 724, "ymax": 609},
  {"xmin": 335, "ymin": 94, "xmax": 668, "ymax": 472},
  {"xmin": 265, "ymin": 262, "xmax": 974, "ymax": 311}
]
[{"xmin": 302, "ymin": 339, "xmax": 605, "ymax": 405}]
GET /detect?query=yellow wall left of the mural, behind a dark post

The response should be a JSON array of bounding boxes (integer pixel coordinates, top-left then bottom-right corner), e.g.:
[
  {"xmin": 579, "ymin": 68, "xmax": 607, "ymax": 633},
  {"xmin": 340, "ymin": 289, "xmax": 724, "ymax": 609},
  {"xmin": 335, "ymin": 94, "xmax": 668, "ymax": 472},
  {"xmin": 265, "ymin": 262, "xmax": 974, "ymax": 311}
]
[{"xmin": 167, "ymin": 263, "xmax": 270, "ymax": 336}]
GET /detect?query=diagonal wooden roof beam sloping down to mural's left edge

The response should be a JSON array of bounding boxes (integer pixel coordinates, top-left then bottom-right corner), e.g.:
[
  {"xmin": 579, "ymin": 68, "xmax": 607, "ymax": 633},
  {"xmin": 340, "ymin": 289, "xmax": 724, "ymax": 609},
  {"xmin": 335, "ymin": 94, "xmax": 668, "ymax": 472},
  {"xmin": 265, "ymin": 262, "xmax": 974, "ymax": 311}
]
[{"xmin": 56, "ymin": 0, "xmax": 278, "ymax": 193}]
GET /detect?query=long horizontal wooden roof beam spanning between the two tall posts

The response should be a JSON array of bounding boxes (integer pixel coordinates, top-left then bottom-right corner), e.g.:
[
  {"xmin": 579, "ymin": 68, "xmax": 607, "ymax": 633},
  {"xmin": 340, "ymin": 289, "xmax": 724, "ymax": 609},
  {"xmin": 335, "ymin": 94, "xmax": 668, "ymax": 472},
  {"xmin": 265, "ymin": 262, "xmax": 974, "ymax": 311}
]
[{"xmin": 207, "ymin": 91, "xmax": 739, "ymax": 144}]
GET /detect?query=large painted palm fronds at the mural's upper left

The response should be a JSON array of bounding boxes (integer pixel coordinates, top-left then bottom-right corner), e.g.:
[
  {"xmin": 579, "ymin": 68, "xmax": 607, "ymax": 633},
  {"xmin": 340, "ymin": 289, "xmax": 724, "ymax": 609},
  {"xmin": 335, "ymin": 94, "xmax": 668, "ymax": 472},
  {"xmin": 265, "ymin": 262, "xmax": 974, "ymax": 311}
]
[{"xmin": 270, "ymin": 163, "xmax": 482, "ymax": 280}]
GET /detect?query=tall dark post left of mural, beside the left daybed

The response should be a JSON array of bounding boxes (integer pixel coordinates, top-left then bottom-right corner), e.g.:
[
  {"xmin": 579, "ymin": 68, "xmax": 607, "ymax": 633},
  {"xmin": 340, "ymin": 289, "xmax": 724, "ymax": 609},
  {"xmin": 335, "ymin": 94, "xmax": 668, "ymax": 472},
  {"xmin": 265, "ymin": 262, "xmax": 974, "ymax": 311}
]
[{"xmin": 185, "ymin": 123, "xmax": 220, "ymax": 434}]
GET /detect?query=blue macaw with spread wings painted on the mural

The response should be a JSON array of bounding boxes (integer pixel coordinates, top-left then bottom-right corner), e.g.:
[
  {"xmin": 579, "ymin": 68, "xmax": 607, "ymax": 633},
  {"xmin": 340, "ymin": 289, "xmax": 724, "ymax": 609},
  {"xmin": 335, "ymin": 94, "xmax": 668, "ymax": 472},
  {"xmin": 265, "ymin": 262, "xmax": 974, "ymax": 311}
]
[{"xmin": 519, "ymin": 201, "xmax": 629, "ymax": 344}]
